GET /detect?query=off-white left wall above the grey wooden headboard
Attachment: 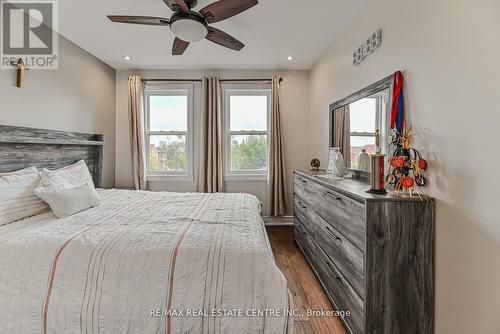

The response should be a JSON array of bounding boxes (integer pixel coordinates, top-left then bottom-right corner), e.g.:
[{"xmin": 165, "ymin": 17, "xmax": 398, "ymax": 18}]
[{"xmin": 0, "ymin": 36, "xmax": 115, "ymax": 187}]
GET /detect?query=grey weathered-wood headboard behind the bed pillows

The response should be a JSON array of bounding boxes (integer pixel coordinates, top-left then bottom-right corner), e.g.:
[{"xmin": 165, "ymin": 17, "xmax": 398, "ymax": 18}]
[{"xmin": 0, "ymin": 125, "xmax": 104, "ymax": 187}]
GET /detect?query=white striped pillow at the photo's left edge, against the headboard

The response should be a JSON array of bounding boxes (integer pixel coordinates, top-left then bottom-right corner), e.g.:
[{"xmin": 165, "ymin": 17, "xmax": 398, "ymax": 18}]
[{"xmin": 0, "ymin": 167, "xmax": 48, "ymax": 226}]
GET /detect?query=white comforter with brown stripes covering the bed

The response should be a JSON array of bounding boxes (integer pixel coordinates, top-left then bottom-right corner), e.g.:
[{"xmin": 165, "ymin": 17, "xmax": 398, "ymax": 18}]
[{"xmin": 0, "ymin": 190, "xmax": 292, "ymax": 334}]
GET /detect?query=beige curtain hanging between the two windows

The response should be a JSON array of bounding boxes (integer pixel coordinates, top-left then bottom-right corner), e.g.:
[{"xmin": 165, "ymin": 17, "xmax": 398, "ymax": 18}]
[{"xmin": 198, "ymin": 78, "xmax": 224, "ymax": 193}]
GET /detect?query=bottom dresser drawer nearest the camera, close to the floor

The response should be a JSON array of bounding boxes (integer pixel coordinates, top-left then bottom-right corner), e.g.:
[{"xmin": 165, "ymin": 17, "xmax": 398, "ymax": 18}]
[{"xmin": 315, "ymin": 245, "xmax": 364, "ymax": 334}]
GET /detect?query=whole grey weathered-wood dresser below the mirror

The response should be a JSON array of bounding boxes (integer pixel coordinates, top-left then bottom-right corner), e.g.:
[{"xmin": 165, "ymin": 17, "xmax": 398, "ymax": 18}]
[{"xmin": 294, "ymin": 171, "xmax": 434, "ymax": 334}]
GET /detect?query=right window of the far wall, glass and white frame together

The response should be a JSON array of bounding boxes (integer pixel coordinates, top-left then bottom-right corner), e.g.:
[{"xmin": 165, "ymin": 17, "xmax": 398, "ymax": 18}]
[{"xmin": 224, "ymin": 84, "xmax": 271, "ymax": 180}]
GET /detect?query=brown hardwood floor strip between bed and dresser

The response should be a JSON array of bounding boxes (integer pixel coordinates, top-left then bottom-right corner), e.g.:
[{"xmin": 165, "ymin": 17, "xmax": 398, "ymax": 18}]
[{"xmin": 267, "ymin": 226, "xmax": 346, "ymax": 334}]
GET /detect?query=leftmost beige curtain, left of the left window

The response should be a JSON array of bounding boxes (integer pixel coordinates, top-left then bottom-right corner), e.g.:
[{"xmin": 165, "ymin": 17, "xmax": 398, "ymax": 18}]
[{"xmin": 128, "ymin": 76, "xmax": 147, "ymax": 190}]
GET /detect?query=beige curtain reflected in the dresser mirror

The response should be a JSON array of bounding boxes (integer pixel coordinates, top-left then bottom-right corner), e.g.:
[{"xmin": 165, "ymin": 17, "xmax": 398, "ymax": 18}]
[{"xmin": 333, "ymin": 105, "xmax": 351, "ymax": 168}]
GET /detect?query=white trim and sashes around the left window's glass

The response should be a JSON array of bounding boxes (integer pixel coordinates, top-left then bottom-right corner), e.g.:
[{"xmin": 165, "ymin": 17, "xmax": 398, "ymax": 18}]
[{"xmin": 144, "ymin": 83, "xmax": 194, "ymax": 182}]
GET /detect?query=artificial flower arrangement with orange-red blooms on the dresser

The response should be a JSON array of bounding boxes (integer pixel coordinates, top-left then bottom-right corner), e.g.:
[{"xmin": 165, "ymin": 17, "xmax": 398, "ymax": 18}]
[{"xmin": 387, "ymin": 127, "xmax": 427, "ymax": 196}]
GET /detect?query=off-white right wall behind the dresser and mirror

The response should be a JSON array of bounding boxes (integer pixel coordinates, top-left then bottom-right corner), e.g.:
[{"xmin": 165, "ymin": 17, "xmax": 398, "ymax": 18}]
[{"xmin": 308, "ymin": 0, "xmax": 500, "ymax": 334}]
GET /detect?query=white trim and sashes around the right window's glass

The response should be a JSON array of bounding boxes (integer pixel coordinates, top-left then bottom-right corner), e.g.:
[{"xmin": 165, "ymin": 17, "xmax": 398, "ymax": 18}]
[{"xmin": 222, "ymin": 83, "xmax": 272, "ymax": 181}]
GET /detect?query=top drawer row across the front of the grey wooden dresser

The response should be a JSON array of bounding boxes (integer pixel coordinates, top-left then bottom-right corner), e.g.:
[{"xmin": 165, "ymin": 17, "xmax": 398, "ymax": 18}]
[{"xmin": 294, "ymin": 175, "xmax": 366, "ymax": 251}]
